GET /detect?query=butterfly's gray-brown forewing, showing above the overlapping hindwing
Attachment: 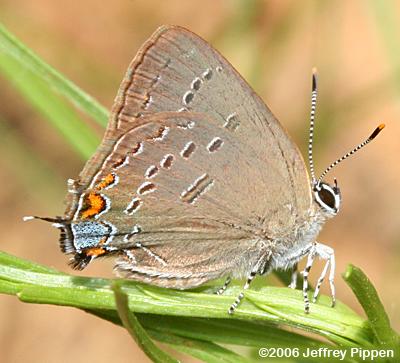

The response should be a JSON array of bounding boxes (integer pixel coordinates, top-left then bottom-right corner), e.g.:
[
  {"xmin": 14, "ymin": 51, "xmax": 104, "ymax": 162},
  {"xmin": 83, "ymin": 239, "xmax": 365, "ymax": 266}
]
[{"xmin": 70, "ymin": 26, "xmax": 311, "ymax": 214}]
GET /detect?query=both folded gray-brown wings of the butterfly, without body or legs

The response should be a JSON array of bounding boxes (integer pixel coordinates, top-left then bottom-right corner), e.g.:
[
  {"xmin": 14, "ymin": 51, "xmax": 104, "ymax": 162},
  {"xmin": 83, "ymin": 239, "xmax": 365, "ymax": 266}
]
[{"xmin": 66, "ymin": 27, "xmax": 311, "ymax": 286}]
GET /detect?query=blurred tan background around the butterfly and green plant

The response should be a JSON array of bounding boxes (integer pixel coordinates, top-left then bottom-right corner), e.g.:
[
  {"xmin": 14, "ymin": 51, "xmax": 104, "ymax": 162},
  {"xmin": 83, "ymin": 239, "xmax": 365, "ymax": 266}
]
[{"xmin": 0, "ymin": 0, "xmax": 400, "ymax": 363}]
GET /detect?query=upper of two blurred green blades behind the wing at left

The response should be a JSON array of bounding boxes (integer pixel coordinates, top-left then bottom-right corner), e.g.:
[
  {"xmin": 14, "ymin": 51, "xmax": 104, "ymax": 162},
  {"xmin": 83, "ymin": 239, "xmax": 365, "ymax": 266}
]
[{"xmin": 0, "ymin": 24, "xmax": 108, "ymax": 126}]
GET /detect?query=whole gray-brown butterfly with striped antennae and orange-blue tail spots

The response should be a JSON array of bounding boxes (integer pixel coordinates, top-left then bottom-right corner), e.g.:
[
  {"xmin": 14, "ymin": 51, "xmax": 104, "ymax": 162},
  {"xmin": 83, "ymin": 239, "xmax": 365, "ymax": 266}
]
[{"xmin": 28, "ymin": 26, "xmax": 384, "ymax": 313}]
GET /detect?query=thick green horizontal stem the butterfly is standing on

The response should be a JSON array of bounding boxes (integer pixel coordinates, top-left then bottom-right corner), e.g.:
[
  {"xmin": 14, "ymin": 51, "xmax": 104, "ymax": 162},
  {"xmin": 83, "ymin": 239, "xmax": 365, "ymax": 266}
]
[{"xmin": 0, "ymin": 253, "xmax": 382, "ymax": 347}]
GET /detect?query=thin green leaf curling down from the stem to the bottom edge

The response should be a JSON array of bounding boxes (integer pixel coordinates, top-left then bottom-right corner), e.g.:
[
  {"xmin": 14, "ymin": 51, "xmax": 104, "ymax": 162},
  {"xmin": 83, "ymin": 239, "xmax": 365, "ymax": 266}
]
[{"xmin": 112, "ymin": 282, "xmax": 178, "ymax": 363}]
